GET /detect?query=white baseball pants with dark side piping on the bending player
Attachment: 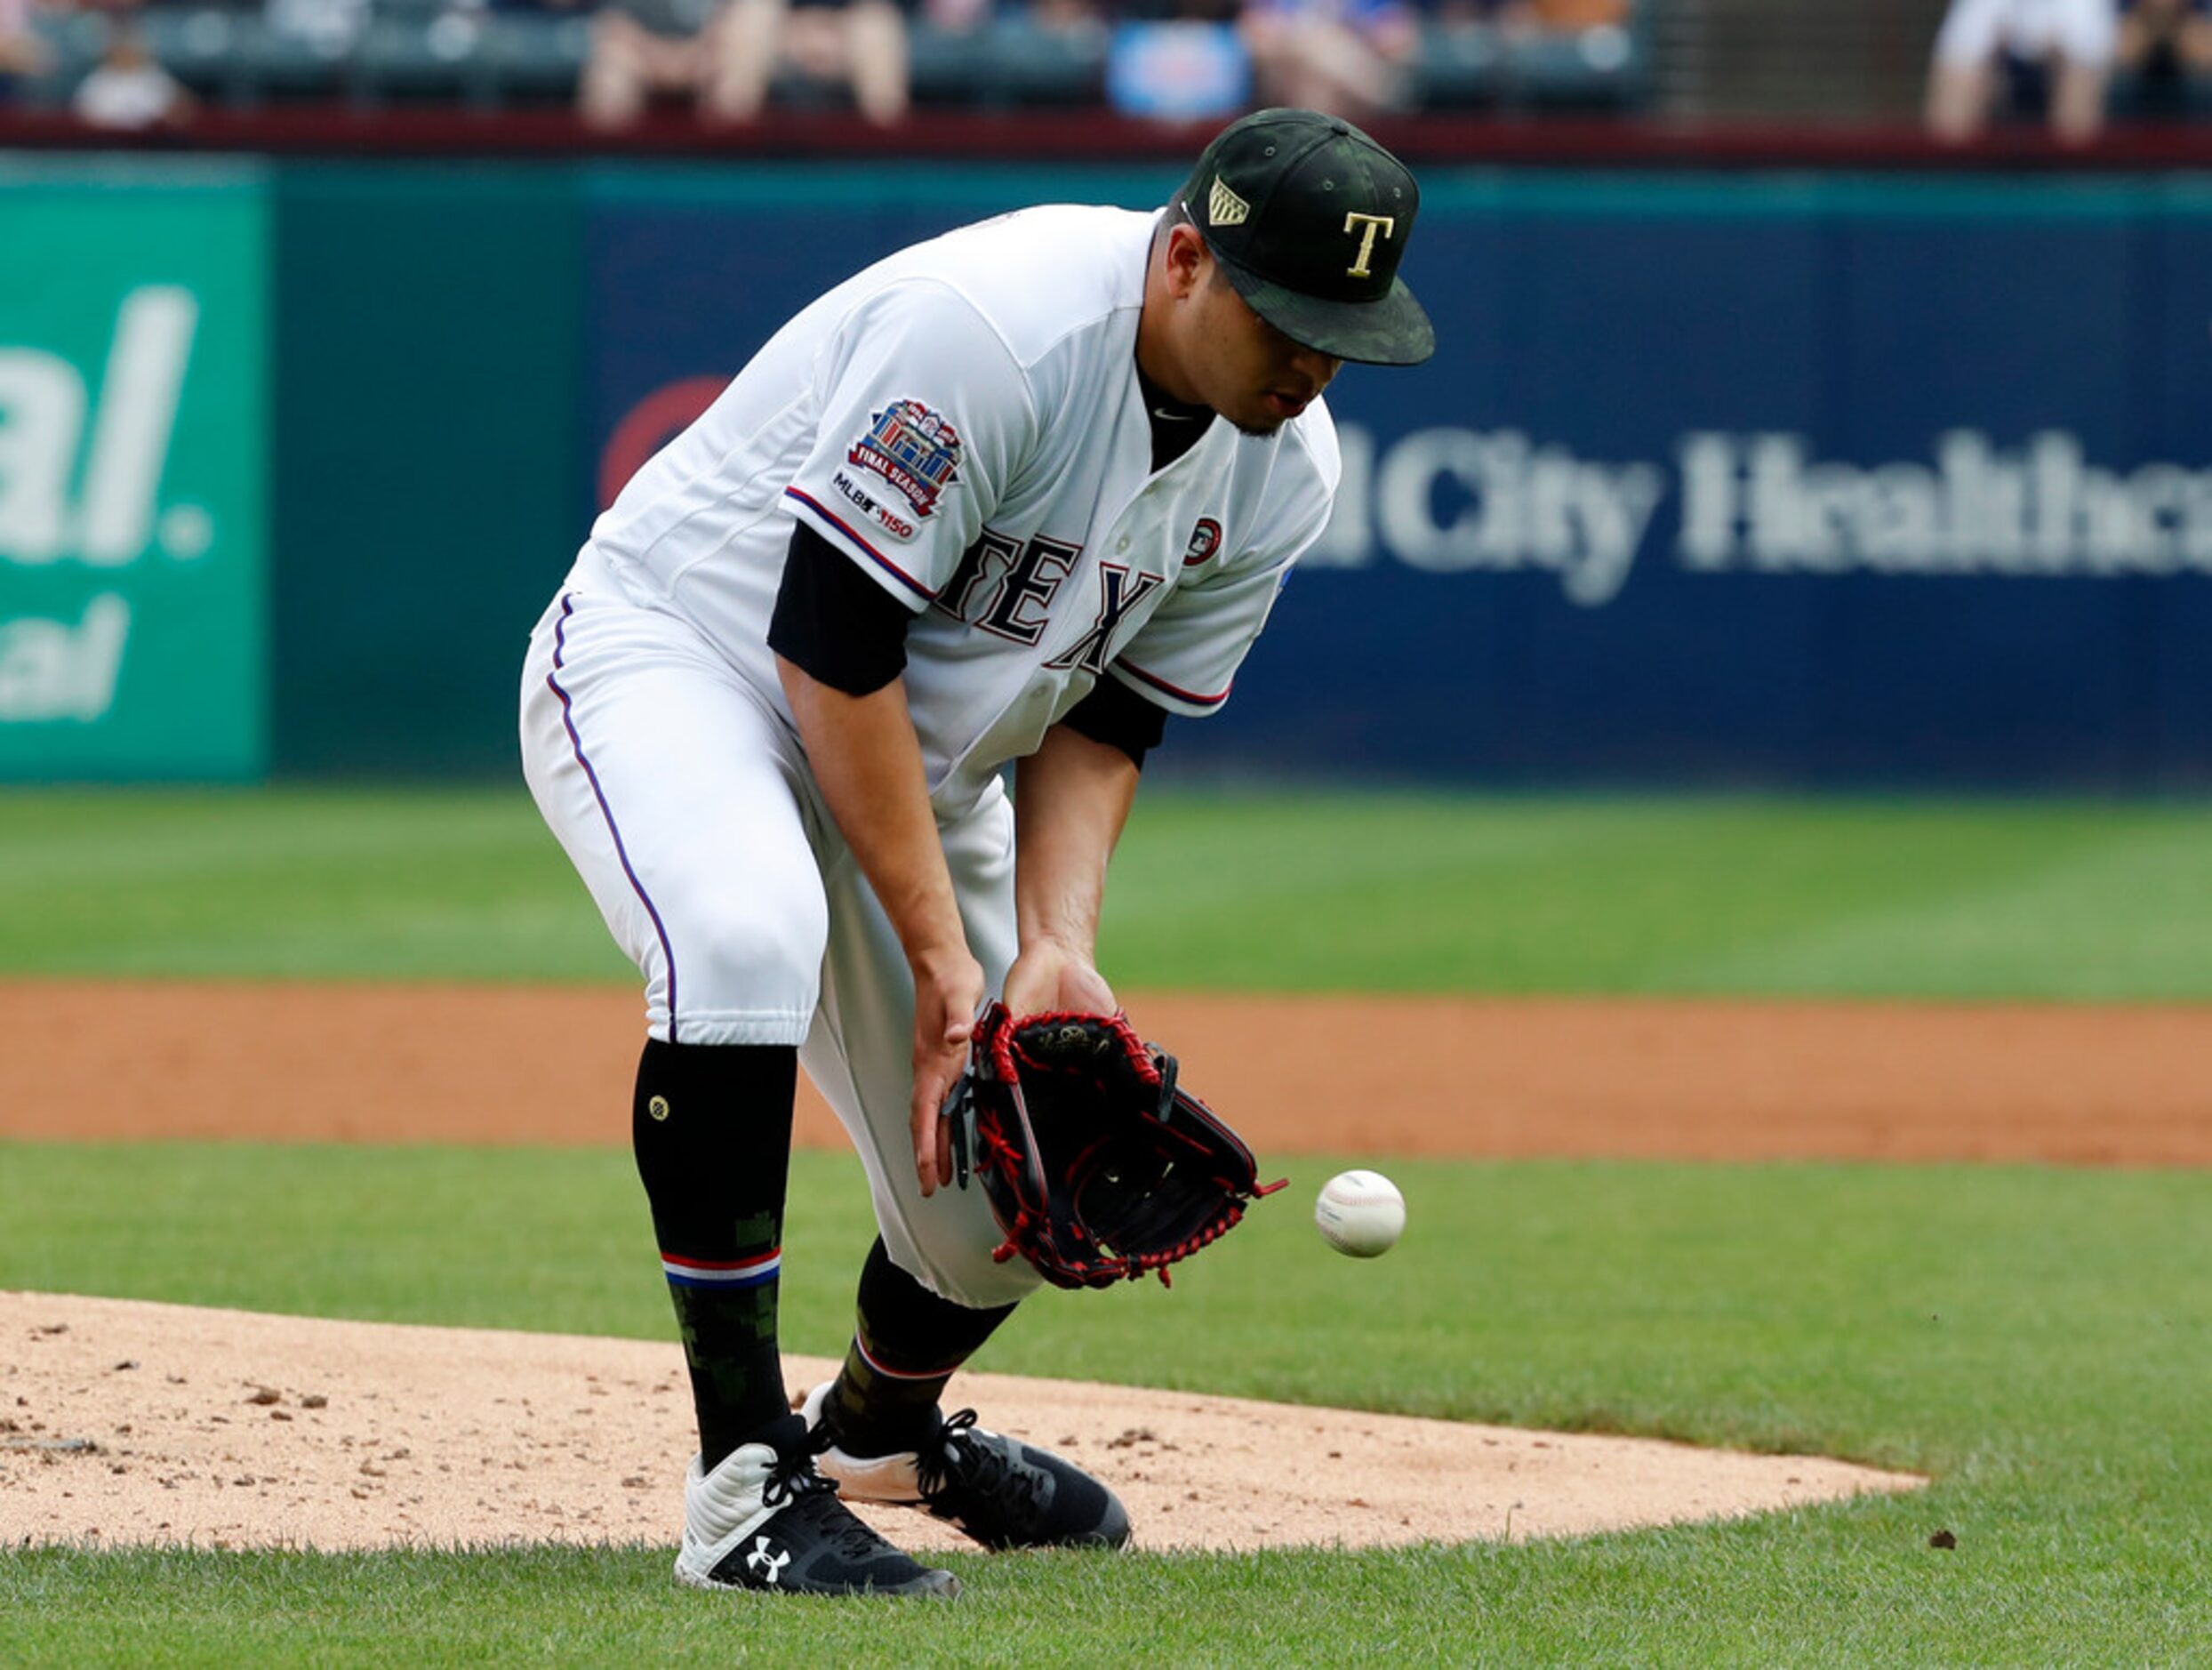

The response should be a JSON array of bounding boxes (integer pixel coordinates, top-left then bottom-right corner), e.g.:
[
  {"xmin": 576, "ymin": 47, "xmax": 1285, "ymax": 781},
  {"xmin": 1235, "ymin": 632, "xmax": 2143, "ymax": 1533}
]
[{"xmin": 522, "ymin": 555, "xmax": 1039, "ymax": 1307}]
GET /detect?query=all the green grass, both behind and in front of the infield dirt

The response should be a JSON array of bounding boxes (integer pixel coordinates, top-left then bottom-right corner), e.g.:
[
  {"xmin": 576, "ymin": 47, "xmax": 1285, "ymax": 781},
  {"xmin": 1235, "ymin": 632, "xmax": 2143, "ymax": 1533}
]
[{"xmin": 0, "ymin": 791, "xmax": 2212, "ymax": 1666}]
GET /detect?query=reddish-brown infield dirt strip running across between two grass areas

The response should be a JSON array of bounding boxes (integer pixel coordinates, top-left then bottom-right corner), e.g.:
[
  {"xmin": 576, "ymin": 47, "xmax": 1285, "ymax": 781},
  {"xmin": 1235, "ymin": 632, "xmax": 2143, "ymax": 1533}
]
[{"xmin": 0, "ymin": 982, "xmax": 2212, "ymax": 1166}]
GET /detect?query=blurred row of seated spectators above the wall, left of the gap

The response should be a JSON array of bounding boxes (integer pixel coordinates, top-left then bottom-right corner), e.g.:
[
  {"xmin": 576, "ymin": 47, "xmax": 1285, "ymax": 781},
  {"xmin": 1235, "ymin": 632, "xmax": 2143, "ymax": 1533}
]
[{"xmin": 0, "ymin": 0, "xmax": 1663, "ymax": 128}]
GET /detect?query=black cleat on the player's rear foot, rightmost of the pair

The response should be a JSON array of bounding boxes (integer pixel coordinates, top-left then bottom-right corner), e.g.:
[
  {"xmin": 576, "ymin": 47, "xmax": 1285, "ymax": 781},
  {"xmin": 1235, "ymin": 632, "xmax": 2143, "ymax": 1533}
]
[{"xmin": 801, "ymin": 1385, "xmax": 1128, "ymax": 1548}]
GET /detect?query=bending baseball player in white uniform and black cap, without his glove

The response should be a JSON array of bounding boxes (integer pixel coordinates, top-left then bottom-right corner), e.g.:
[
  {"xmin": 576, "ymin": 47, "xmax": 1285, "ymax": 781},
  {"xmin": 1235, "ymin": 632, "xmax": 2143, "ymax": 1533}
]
[{"xmin": 522, "ymin": 110, "xmax": 1433, "ymax": 1594}]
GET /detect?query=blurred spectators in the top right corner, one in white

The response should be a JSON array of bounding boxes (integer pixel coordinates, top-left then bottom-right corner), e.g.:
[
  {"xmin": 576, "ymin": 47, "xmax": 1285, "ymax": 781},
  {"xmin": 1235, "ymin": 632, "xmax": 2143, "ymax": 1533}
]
[{"xmin": 1927, "ymin": 0, "xmax": 2212, "ymax": 144}]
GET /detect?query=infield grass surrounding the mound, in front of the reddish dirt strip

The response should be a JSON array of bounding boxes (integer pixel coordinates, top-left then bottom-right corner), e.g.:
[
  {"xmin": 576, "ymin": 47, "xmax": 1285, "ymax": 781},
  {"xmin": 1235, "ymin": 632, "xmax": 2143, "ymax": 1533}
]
[{"xmin": 0, "ymin": 1144, "xmax": 2212, "ymax": 1666}]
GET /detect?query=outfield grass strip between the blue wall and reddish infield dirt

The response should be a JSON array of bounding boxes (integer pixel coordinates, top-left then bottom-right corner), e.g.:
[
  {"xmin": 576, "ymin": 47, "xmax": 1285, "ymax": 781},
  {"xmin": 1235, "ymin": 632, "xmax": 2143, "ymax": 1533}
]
[{"xmin": 0, "ymin": 788, "xmax": 2212, "ymax": 1000}]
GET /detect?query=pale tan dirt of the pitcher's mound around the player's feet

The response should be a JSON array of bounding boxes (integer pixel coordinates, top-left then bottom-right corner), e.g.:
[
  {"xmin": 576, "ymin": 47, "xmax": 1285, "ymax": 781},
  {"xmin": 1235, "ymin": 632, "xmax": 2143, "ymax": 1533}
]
[{"xmin": 0, "ymin": 1294, "xmax": 1925, "ymax": 1548}]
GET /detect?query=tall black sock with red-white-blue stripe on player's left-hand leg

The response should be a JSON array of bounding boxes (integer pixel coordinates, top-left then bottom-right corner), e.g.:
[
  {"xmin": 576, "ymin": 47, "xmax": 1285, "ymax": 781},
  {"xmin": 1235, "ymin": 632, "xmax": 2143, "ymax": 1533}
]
[{"xmin": 630, "ymin": 1040, "xmax": 798, "ymax": 1471}]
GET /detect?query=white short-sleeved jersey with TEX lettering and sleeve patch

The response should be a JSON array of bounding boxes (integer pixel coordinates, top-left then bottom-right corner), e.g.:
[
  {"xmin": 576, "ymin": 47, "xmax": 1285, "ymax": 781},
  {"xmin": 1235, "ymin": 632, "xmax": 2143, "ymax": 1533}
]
[{"xmin": 590, "ymin": 205, "xmax": 1338, "ymax": 812}]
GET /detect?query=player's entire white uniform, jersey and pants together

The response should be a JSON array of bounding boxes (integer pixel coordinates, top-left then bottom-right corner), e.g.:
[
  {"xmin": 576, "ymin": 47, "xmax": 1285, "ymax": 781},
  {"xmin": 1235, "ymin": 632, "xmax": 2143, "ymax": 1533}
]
[{"xmin": 522, "ymin": 208, "xmax": 1338, "ymax": 1305}]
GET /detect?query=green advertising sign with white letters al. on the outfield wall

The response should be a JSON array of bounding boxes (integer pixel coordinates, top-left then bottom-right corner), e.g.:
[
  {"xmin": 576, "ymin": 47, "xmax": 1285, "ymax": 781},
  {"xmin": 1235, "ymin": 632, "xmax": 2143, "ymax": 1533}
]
[{"xmin": 0, "ymin": 175, "xmax": 266, "ymax": 779}]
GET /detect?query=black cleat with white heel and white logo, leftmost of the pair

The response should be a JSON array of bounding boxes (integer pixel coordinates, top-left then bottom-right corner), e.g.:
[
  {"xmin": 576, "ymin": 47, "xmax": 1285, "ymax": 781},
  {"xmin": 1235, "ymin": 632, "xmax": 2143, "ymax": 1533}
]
[{"xmin": 677, "ymin": 1422, "xmax": 960, "ymax": 1599}]
